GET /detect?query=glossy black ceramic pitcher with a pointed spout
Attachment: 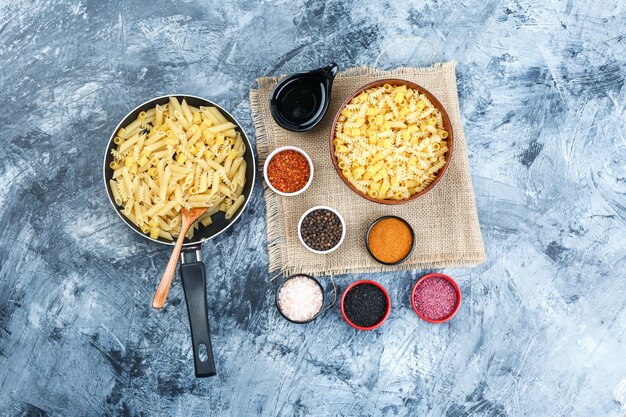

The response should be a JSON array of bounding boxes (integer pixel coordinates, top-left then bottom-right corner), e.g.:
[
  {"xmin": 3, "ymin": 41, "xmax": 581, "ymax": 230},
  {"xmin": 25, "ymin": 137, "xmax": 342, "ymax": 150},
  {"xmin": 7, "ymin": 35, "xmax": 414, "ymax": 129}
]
[{"xmin": 270, "ymin": 62, "xmax": 339, "ymax": 132}]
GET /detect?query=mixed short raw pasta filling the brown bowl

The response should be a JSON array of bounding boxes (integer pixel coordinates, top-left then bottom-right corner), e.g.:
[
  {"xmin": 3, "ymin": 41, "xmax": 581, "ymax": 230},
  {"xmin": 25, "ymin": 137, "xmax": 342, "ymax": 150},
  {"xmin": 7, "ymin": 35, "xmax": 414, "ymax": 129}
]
[{"xmin": 333, "ymin": 84, "xmax": 448, "ymax": 200}]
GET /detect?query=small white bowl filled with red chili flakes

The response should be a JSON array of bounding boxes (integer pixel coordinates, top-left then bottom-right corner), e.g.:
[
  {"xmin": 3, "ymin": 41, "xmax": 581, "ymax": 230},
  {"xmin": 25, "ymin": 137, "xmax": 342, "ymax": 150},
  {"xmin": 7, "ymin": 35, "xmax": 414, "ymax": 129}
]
[{"xmin": 263, "ymin": 146, "xmax": 313, "ymax": 196}]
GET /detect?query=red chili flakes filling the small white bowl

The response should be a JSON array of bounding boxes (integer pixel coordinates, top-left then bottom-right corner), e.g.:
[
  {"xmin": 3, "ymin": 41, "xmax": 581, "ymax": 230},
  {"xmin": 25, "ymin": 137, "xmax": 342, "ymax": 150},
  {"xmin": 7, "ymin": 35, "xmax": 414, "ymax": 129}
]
[{"xmin": 267, "ymin": 150, "xmax": 311, "ymax": 193}]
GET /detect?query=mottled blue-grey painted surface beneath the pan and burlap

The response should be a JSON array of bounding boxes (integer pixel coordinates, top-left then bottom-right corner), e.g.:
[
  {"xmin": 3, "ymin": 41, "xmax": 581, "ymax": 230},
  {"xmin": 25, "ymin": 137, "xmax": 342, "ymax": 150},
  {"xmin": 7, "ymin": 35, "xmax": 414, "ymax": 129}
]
[{"xmin": 0, "ymin": 0, "xmax": 626, "ymax": 417}]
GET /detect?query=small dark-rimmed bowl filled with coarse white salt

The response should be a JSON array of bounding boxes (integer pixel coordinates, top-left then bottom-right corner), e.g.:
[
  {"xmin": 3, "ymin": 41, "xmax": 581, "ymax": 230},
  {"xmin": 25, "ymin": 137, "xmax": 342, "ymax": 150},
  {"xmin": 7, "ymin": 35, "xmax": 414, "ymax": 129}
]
[{"xmin": 276, "ymin": 274, "xmax": 324, "ymax": 324}]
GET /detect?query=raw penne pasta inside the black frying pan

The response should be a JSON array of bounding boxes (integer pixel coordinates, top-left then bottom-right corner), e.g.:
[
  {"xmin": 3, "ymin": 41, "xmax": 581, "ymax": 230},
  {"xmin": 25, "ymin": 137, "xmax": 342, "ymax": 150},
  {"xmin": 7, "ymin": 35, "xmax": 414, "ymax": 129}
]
[{"xmin": 110, "ymin": 97, "xmax": 246, "ymax": 240}]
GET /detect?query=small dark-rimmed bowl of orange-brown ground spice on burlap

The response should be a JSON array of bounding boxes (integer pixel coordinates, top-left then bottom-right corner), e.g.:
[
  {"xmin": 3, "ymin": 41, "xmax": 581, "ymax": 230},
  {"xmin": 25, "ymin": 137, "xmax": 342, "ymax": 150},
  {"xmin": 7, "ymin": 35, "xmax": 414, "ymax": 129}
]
[{"xmin": 365, "ymin": 216, "xmax": 415, "ymax": 265}]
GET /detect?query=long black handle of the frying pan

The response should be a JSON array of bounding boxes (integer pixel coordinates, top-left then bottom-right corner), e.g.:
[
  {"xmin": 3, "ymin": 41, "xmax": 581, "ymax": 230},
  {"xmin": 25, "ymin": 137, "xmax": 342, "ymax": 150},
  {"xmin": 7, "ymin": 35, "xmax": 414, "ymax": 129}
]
[{"xmin": 180, "ymin": 246, "xmax": 217, "ymax": 378}]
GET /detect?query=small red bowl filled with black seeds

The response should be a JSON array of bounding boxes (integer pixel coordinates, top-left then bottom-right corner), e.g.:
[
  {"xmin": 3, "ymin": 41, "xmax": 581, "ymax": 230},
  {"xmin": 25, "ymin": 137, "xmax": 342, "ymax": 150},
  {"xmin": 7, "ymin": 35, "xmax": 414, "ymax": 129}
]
[{"xmin": 340, "ymin": 280, "xmax": 391, "ymax": 330}]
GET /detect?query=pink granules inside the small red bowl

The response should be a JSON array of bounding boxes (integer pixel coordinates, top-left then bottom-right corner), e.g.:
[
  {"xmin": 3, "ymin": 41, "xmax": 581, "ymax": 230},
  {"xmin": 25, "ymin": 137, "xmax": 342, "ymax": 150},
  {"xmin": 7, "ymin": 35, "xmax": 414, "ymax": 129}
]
[{"xmin": 413, "ymin": 277, "xmax": 459, "ymax": 320}]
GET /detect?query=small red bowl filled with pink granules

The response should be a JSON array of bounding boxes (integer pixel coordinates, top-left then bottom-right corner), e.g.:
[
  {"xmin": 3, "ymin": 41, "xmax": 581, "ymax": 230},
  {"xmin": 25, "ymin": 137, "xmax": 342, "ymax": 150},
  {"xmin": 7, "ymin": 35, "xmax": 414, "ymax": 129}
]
[{"xmin": 411, "ymin": 273, "xmax": 461, "ymax": 323}]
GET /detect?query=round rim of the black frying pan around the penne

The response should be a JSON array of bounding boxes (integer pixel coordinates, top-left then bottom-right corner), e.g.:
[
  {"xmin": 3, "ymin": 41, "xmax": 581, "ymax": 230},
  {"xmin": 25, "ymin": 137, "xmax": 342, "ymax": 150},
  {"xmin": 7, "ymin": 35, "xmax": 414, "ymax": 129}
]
[{"xmin": 102, "ymin": 93, "xmax": 256, "ymax": 248}]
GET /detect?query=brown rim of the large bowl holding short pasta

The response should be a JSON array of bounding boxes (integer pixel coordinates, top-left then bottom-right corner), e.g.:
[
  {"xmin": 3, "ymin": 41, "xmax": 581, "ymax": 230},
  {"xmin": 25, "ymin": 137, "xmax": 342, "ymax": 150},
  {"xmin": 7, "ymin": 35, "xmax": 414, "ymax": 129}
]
[{"xmin": 330, "ymin": 78, "xmax": 454, "ymax": 204}]
